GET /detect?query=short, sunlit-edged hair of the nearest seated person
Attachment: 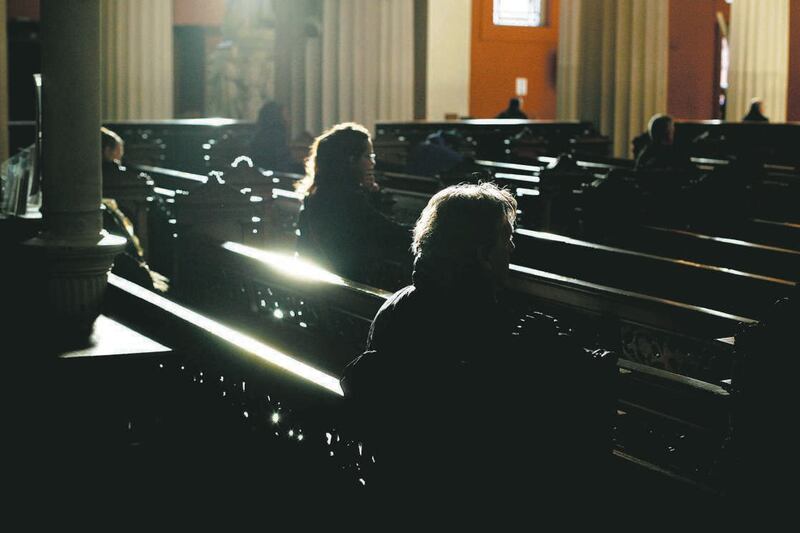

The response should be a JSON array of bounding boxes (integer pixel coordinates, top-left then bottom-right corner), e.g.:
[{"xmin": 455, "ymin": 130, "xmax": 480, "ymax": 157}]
[{"xmin": 411, "ymin": 183, "xmax": 517, "ymax": 268}]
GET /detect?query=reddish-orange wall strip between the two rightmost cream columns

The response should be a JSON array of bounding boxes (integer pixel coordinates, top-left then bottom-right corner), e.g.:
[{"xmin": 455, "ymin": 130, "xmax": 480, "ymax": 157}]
[{"xmin": 667, "ymin": 0, "xmax": 730, "ymax": 119}]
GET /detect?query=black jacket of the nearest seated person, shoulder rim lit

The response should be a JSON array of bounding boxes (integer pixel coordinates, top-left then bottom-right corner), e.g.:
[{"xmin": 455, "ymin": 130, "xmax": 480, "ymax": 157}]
[{"xmin": 342, "ymin": 266, "xmax": 610, "ymax": 512}]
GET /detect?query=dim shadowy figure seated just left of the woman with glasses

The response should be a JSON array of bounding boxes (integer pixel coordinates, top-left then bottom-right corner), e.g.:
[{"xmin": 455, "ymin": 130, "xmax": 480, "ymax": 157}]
[{"xmin": 250, "ymin": 101, "xmax": 303, "ymax": 174}]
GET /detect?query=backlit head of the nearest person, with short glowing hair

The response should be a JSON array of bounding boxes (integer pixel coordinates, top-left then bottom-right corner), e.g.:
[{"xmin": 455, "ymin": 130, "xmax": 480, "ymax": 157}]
[{"xmin": 411, "ymin": 183, "xmax": 517, "ymax": 288}]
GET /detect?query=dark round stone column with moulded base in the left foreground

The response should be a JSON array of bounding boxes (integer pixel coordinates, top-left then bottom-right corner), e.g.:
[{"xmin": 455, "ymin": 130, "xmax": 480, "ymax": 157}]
[{"xmin": 24, "ymin": 0, "xmax": 125, "ymax": 345}]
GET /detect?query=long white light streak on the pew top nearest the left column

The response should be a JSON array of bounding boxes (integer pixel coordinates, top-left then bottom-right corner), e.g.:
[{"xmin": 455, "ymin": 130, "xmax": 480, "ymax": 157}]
[{"xmin": 108, "ymin": 274, "xmax": 344, "ymax": 396}]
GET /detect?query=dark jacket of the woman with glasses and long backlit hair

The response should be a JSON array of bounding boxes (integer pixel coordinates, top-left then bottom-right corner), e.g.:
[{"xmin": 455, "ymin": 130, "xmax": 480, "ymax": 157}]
[{"xmin": 297, "ymin": 188, "xmax": 411, "ymax": 284}]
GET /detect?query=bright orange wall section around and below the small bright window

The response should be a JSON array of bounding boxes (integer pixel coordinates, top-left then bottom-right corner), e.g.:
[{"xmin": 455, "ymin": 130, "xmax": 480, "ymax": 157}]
[{"xmin": 469, "ymin": 0, "xmax": 558, "ymax": 119}]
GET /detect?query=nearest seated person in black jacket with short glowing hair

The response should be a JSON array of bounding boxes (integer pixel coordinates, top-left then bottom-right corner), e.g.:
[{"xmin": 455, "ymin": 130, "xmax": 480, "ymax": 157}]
[{"xmin": 341, "ymin": 183, "xmax": 616, "ymax": 513}]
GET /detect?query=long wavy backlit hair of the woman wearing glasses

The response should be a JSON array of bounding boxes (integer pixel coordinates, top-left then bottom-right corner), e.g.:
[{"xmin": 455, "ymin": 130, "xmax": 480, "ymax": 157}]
[{"xmin": 298, "ymin": 122, "xmax": 370, "ymax": 194}]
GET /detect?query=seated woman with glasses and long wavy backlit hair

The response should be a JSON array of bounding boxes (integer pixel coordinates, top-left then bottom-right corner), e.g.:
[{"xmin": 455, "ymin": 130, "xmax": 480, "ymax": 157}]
[{"xmin": 297, "ymin": 123, "xmax": 411, "ymax": 284}]
